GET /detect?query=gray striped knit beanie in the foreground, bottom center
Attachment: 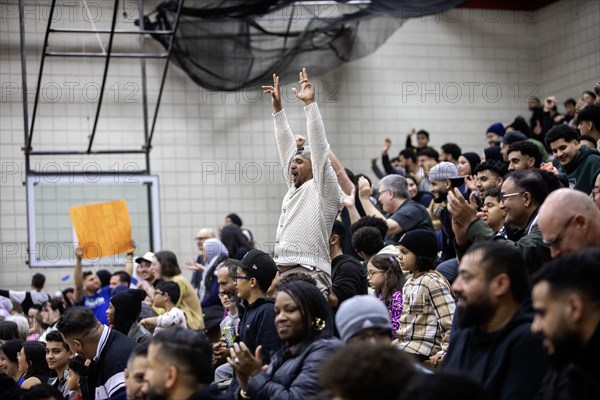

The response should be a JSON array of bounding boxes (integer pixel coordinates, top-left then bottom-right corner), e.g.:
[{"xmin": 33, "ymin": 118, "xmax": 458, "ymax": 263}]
[{"xmin": 335, "ymin": 295, "xmax": 392, "ymax": 343}]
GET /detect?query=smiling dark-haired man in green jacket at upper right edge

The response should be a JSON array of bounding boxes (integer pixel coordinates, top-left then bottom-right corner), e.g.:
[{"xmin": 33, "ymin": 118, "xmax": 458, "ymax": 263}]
[{"xmin": 546, "ymin": 125, "xmax": 600, "ymax": 194}]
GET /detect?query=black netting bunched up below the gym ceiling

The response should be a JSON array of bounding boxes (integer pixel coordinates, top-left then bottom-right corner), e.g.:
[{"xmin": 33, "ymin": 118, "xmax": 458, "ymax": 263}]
[{"xmin": 145, "ymin": 0, "xmax": 465, "ymax": 91}]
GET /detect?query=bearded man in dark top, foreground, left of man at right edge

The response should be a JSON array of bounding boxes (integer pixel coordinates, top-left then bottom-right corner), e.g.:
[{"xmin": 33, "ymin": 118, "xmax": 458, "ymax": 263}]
[{"xmin": 443, "ymin": 241, "xmax": 547, "ymax": 400}]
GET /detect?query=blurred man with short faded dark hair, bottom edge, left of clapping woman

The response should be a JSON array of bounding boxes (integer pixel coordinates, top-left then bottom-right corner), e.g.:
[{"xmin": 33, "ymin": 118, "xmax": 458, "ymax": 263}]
[{"xmin": 144, "ymin": 327, "xmax": 228, "ymax": 400}]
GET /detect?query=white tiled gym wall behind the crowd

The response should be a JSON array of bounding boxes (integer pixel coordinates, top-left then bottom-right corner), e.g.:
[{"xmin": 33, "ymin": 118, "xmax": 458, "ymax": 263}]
[{"xmin": 0, "ymin": 0, "xmax": 600, "ymax": 290}]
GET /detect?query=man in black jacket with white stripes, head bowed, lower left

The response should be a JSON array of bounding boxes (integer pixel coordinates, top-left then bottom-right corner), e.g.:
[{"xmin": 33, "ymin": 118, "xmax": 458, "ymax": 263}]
[{"xmin": 57, "ymin": 307, "xmax": 136, "ymax": 400}]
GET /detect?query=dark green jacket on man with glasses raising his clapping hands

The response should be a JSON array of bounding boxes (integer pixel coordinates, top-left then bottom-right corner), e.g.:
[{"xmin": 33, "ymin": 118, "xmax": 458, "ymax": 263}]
[{"xmin": 457, "ymin": 210, "xmax": 552, "ymax": 274}]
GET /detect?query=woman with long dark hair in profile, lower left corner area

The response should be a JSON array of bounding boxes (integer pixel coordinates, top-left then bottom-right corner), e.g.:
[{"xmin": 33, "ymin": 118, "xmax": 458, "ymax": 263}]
[{"xmin": 17, "ymin": 342, "xmax": 50, "ymax": 389}]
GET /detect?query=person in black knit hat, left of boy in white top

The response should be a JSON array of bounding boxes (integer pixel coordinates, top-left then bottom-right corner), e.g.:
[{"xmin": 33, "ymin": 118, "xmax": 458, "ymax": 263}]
[{"xmin": 106, "ymin": 289, "xmax": 151, "ymax": 343}]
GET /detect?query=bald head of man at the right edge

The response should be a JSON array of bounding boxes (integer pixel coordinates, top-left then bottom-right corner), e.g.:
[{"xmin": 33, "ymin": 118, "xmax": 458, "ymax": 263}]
[{"xmin": 538, "ymin": 189, "xmax": 600, "ymax": 257}]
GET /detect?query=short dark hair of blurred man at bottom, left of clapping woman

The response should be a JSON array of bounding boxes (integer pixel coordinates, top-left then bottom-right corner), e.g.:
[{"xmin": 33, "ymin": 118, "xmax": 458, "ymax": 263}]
[{"xmin": 150, "ymin": 326, "xmax": 213, "ymax": 385}]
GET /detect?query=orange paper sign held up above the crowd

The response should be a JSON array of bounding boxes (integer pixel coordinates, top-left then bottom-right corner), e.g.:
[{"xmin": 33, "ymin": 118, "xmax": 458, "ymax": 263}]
[{"xmin": 69, "ymin": 200, "xmax": 133, "ymax": 259}]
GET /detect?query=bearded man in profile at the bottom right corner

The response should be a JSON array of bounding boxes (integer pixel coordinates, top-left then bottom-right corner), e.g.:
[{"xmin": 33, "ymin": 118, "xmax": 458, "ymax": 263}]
[{"xmin": 531, "ymin": 247, "xmax": 600, "ymax": 400}]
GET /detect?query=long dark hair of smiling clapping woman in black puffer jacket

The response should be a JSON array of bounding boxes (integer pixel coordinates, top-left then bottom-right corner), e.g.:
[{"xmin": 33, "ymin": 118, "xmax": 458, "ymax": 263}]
[{"xmin": 277, "ymin": 280, "xmax": 333, "ymax": 342}]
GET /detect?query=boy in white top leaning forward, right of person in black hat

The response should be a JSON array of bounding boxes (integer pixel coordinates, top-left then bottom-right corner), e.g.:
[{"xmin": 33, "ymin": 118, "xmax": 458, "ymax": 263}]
[{"xmin": 140, "ymin": 281, "xmax": 187, "ymax": 335}]
